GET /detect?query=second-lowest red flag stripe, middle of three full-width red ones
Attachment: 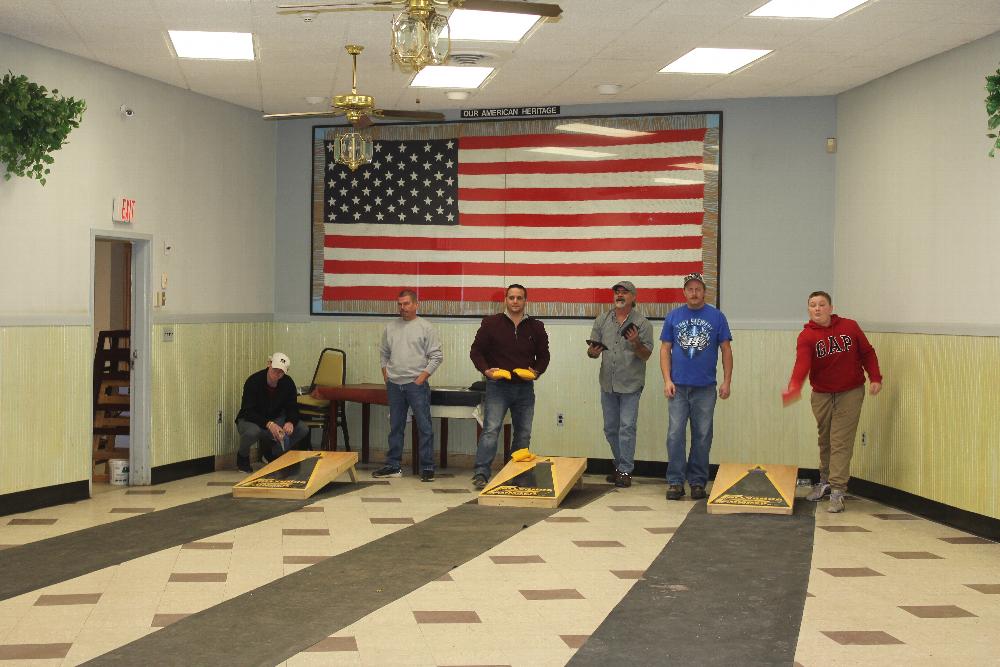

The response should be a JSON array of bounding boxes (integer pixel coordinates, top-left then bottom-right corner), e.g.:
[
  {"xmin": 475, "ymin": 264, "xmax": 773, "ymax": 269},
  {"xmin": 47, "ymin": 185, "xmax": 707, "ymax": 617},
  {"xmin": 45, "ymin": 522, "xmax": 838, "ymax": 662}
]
[{"xmin": 323, "ymin": 259, "xmax": 702, "ymax": 277}]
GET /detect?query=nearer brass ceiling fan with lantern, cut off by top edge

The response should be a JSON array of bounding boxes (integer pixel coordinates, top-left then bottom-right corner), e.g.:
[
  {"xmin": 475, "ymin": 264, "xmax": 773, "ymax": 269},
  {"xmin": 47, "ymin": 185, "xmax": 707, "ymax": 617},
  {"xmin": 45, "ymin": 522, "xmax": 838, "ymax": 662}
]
[{"xmin": 278, "ymin": 0, "xmax": 562, "ymax": 72}]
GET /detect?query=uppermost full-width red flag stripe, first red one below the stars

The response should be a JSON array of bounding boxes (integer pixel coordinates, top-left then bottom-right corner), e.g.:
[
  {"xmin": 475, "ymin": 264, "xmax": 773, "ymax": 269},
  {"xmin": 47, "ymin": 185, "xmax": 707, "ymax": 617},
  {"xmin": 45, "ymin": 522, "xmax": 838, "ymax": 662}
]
[{"xmin": 325, "ymin": 234, "xmax": 701, "ymax": 252}]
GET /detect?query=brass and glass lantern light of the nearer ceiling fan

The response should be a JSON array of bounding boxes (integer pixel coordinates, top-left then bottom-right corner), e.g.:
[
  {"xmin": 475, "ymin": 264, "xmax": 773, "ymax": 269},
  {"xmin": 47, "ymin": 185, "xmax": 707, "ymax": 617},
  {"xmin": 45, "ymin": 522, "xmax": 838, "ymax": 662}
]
[{"xmin": 392, "ymin": 0, "xmax": 451, "ymax": 72}]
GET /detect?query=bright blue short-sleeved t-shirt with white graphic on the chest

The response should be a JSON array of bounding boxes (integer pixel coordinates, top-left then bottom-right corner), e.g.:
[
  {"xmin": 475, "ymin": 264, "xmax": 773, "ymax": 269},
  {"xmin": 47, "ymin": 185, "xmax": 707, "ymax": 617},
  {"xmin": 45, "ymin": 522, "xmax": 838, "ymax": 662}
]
[{"xmin": 660, "ymin": 304, "xmax": 733, "ymax": 387}]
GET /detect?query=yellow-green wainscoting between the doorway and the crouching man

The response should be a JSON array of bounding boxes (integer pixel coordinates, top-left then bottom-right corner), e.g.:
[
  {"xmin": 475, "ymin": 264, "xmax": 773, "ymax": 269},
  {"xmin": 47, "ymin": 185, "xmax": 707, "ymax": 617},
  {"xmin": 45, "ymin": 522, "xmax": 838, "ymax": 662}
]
[{"xmin": 152, "ymin": 322, "xmax": 272, "ymax": 467}]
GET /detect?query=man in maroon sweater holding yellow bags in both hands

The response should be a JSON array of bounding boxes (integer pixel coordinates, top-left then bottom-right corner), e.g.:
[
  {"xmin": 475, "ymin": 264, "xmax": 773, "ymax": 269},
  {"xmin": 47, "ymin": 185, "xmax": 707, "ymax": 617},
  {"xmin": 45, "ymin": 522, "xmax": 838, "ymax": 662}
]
[{"xmin": 469, "ymin": 284, "xmax": 549, "ymax": 489}]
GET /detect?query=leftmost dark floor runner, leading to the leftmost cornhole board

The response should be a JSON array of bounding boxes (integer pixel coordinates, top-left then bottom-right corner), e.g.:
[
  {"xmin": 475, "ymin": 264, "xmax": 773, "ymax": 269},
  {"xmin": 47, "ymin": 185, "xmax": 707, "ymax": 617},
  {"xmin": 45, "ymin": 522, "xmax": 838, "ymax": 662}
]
[{"xmin": 0, "ymin": 482, "xmax": 366, "ymax": 600}]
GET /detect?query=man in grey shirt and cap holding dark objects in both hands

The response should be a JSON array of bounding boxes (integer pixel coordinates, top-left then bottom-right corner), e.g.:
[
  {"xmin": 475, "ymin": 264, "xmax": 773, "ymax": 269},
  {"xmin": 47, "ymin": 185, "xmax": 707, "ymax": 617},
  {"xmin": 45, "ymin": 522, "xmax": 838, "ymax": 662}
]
[{"xmin": 587, "ymin": 280, "xmax": 653, "ymax": 487}]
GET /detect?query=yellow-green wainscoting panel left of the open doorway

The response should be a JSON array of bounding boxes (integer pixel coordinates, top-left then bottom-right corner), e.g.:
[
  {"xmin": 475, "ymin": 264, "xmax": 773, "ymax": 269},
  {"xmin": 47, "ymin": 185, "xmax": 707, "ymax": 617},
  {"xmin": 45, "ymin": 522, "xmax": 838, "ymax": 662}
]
[{"xmin": 0, "ymin": 326, "xmax": 94, "ymax": 494}]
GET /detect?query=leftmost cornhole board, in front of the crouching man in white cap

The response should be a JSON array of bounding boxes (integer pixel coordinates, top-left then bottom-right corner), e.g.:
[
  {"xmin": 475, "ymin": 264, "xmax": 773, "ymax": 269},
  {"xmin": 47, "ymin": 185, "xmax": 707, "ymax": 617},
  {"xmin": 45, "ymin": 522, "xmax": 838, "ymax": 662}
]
[{"xmin": 233, "ymin": 451, "xmax": 358, "ymax": 500}]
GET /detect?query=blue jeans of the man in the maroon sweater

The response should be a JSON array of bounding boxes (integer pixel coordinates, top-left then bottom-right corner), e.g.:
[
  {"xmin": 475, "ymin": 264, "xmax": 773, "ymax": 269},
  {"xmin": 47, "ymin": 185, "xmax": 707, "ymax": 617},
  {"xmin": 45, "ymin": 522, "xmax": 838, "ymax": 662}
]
[{"xmin": 475, "ymin": 380, "xmax": 535, "ymax": 479}]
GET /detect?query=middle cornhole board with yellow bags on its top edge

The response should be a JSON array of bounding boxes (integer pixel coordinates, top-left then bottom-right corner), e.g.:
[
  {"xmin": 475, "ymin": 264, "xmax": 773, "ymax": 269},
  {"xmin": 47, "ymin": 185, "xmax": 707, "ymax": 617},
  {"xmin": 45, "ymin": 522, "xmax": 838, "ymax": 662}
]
[{"xmin": 479, "ymin": 456, "xmax": 587, "ymax": 508}]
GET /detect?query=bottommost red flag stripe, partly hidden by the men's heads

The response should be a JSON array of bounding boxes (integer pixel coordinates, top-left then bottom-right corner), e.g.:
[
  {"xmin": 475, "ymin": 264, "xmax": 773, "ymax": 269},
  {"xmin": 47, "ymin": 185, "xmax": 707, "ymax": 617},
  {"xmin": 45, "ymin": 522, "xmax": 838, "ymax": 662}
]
[{"xmin": 323, "ymin": 285, "xmax": 684, "ymax": 304}]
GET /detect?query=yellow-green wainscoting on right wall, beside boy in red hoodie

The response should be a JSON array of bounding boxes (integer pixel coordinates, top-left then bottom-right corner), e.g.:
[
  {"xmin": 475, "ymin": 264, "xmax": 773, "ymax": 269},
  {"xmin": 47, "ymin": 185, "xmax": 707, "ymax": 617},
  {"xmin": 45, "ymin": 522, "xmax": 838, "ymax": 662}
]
[{"xmin": 852, "ymin": 333, "xmax": 1000, "ymax": 518}]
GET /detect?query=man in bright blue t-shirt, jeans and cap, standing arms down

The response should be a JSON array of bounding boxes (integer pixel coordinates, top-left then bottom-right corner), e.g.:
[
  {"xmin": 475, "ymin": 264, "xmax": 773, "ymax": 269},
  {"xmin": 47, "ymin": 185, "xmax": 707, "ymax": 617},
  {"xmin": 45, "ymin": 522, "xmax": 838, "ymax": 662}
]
[{"xmin": 660, "ymin": 273, "xmax": 733, "ymax": 500}]
